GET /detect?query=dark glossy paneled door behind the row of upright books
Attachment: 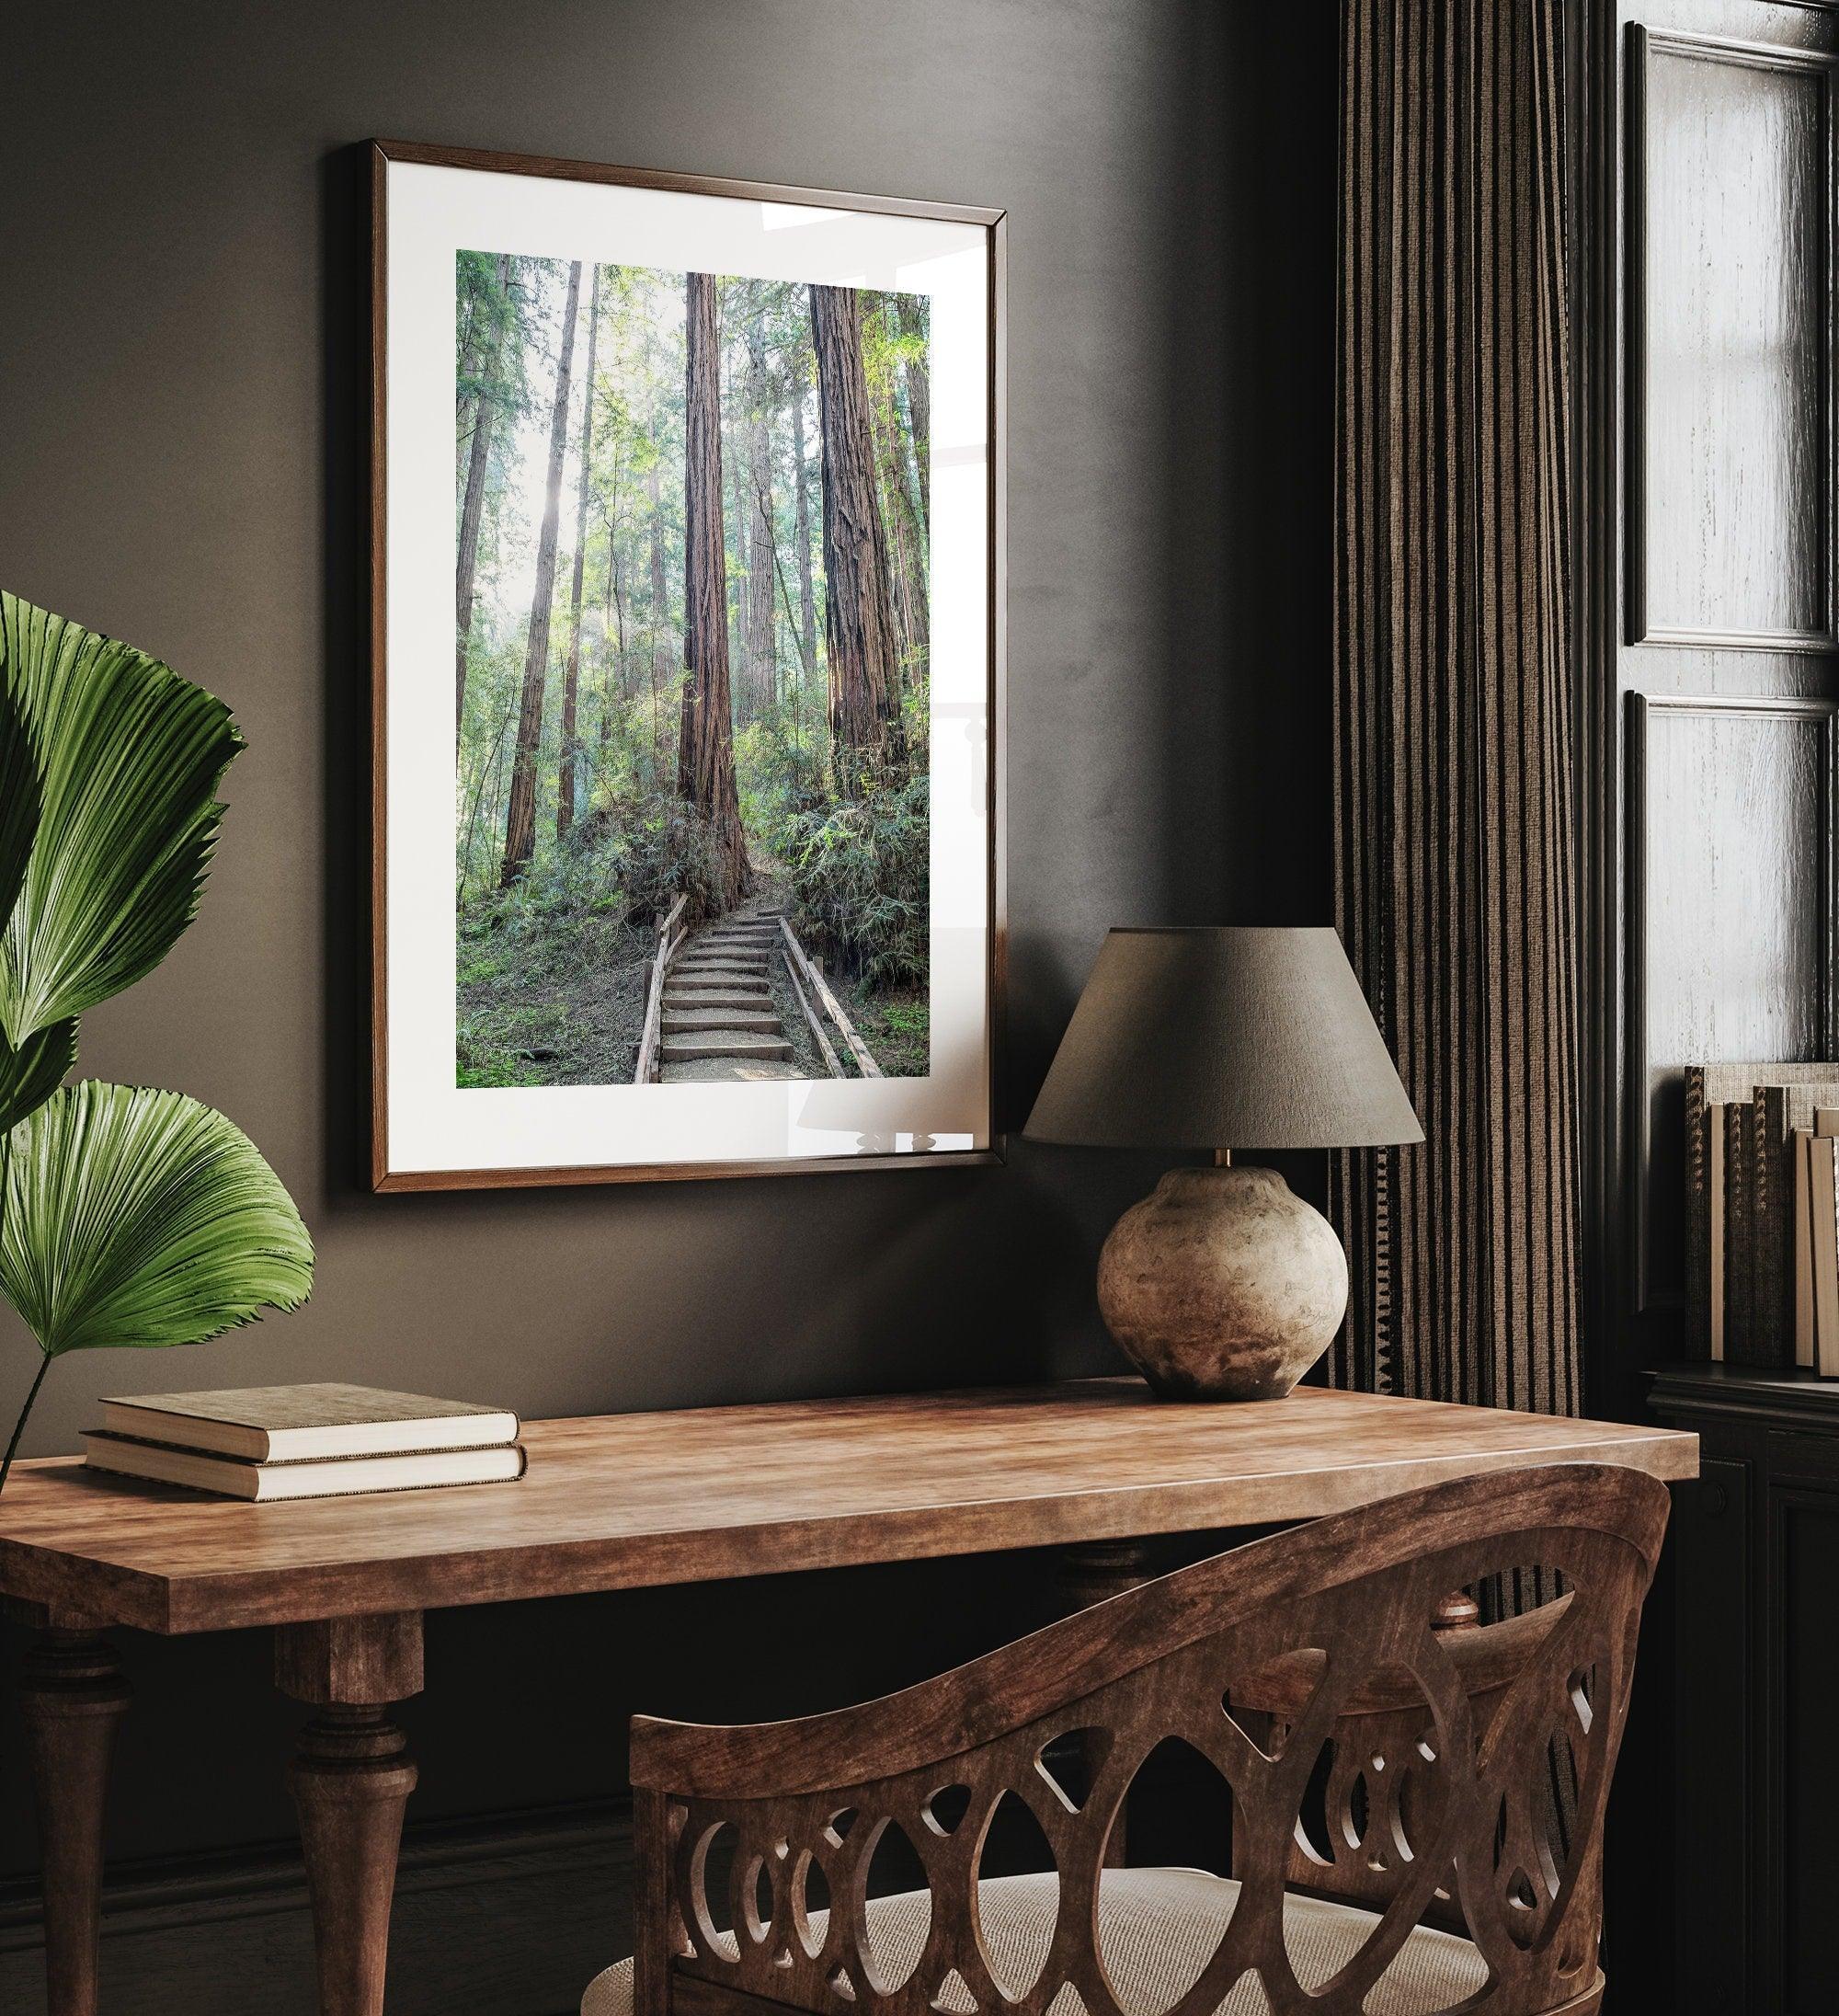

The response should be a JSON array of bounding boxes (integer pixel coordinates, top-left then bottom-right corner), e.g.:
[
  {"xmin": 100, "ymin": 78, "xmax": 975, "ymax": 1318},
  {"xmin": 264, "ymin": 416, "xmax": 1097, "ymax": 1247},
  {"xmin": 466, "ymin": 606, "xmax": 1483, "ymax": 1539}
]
[{"xmin": 1582, "ymin": 0, "xmax": 1839, "ymax": 1369}]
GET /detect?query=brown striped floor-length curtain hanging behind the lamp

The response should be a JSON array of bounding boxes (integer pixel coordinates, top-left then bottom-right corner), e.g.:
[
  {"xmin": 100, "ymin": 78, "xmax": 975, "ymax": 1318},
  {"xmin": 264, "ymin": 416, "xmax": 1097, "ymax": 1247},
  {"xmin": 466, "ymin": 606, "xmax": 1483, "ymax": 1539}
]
[{"xmin": 1333, "ymin": 0, "xmax": 1579, "ymax": 1414}]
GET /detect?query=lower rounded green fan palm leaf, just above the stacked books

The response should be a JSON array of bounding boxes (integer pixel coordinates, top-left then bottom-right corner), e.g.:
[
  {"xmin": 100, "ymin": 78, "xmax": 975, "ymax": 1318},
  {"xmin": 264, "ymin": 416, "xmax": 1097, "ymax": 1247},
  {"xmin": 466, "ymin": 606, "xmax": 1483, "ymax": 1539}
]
[{"xmin": 0, "ymin": 1079, "xmax": 313, "ymax": 1358}]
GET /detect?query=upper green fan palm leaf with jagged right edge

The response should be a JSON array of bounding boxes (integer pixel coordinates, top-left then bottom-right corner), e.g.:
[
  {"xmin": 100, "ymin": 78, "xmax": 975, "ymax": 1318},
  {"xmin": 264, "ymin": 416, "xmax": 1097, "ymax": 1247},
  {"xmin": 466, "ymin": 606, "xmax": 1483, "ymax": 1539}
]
[{"xmin": 0, "ymin": 592, "xmax": 242, "ymax": 1050}]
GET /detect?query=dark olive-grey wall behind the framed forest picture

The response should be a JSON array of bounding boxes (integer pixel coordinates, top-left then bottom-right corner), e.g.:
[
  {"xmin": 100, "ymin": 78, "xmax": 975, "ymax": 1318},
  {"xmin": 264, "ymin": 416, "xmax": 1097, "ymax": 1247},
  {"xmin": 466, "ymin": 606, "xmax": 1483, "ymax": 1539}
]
[{"xmin": 0, "ymin": 0, "xmax": 1335, "ymax": 1867}]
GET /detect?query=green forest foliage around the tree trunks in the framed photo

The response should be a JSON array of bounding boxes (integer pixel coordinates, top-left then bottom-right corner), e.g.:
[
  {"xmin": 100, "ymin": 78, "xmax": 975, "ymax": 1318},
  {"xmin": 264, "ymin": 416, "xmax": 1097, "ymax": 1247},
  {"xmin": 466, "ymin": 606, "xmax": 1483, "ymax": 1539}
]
[{"xmin": 456, "ymin": 252, "xmax": 930, "ymax": 1084}]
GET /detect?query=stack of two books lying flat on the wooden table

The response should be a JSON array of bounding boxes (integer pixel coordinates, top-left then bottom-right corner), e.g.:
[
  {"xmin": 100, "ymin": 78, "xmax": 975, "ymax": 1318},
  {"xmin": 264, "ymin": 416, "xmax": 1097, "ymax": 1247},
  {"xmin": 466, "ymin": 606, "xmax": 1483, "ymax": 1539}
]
[{"xmin": 83, "ymin": 1385, "xmax": 524, "ymax": 1502}]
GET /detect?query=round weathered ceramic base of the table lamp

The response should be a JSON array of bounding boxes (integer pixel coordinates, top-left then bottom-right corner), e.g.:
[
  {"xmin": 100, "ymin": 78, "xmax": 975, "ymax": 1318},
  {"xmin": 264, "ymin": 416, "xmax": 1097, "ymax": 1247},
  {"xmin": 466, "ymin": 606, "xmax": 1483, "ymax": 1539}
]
[{"xmin": 1099, "ymin": 1167, "xmax": 1347, "ymax": 1399}]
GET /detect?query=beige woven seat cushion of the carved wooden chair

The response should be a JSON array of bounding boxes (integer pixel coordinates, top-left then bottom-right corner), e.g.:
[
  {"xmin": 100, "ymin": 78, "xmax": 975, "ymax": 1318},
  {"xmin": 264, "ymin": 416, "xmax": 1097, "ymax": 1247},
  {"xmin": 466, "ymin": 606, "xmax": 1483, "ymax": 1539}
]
[{"xmin": 581, "ymin": 1869, "xmax": 1488, "ymax": 2016}]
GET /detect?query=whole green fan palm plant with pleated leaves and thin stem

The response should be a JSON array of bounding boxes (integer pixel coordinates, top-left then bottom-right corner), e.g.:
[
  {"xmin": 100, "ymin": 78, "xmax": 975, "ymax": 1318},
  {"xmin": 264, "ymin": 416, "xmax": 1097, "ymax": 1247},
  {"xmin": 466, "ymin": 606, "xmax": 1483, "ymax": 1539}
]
[{"xmin": 0, "ymin": 592, "xmax": 313, "ymax": 1486}]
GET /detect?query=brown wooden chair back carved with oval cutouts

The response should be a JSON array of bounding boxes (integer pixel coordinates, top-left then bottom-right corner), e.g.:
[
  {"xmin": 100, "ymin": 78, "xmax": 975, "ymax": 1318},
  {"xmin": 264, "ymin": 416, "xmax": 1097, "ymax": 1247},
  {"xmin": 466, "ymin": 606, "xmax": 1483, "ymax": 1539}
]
[{"xmin": 634, "ymin": 1463, "xmax": 1668, "ymax": 2016}]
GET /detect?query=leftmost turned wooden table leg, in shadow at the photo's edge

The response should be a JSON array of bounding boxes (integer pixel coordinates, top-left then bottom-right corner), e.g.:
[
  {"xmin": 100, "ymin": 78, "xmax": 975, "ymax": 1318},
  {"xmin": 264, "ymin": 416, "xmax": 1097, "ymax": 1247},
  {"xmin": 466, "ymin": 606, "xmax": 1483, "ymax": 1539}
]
[{"xmin": 20, "ymin": 1631, "xmax": 129, "ymax": 2016}]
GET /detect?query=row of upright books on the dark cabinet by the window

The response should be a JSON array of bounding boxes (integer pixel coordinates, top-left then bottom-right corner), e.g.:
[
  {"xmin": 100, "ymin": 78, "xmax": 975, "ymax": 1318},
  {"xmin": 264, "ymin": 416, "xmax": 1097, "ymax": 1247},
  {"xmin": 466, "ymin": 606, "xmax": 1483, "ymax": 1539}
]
[{"xmin": 1685, "ymin": 1062, "xmax": 1839, "ymax": 1377}]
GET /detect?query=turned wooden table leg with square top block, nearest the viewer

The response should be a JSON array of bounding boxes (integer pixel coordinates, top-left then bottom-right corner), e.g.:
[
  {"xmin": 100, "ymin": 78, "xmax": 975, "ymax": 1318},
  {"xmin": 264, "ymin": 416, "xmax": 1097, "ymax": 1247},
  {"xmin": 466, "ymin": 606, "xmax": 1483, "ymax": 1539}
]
[{"xmin": 274, "ymin": 1610, "xmax": 421, "ymax": 2016}]
